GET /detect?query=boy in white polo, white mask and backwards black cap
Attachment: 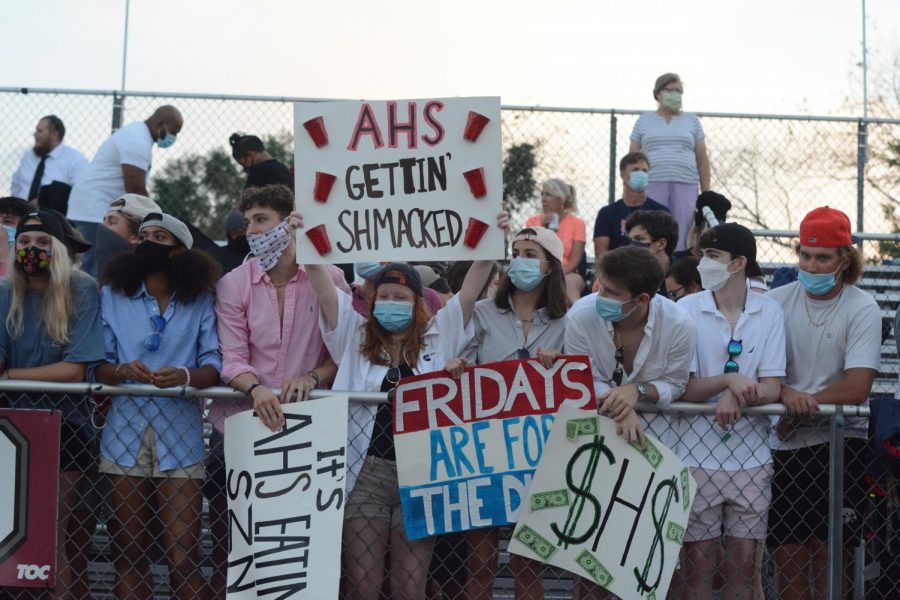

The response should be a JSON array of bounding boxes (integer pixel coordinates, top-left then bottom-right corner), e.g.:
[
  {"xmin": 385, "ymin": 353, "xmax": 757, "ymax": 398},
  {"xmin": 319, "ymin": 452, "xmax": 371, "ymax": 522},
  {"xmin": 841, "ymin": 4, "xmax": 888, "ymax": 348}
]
[{"xmin": 675, "ymin": 223, "xmax": 785, "ymax": 600}]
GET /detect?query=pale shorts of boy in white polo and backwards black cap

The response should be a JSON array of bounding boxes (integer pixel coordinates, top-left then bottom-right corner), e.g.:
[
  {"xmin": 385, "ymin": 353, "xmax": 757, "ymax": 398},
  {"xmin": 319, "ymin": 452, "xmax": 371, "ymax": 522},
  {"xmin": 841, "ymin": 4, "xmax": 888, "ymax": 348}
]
[{"xmin": 684, "ymin": 465, "xmax": 772, "ymax": 542}]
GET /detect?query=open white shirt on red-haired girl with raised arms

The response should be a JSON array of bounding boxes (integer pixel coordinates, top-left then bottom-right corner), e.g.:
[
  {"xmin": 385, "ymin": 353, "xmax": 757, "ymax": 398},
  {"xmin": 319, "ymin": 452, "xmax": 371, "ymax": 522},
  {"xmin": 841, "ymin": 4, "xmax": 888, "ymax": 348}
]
[{"xmin": 319, "ymin": 290, "xmax": 475, "ymax": 494}]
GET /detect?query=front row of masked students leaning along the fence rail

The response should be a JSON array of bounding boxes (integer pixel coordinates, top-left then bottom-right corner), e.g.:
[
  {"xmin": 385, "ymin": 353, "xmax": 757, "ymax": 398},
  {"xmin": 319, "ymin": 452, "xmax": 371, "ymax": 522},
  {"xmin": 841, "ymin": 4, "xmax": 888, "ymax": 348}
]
[{"xmin": 0, "ymin": 171, "xmax": 881, "ymax": 598}]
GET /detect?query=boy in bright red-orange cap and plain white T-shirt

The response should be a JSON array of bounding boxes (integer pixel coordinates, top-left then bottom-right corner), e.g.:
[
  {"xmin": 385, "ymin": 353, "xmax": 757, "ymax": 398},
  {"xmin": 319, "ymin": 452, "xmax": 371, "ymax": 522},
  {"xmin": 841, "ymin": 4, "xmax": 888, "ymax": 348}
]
[{"xmin": 767, "ymin": 207, "xmax": 881, "ymax": 600}]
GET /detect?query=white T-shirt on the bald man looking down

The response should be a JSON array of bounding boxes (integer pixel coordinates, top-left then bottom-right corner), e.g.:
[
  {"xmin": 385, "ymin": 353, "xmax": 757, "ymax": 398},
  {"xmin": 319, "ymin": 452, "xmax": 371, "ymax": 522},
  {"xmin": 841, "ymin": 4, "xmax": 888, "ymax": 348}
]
[{"xmin": 66, "ymin": 121, "xmax": 153, "ymax": 223}]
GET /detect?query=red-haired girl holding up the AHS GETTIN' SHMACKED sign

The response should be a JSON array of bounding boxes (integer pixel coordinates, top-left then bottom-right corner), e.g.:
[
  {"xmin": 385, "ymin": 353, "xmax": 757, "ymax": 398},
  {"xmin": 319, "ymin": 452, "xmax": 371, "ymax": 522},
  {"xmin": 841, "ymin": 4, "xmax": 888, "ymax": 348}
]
[{"xmin": 289, "ymin": 211, "xmax": 508, "ymax": 600}]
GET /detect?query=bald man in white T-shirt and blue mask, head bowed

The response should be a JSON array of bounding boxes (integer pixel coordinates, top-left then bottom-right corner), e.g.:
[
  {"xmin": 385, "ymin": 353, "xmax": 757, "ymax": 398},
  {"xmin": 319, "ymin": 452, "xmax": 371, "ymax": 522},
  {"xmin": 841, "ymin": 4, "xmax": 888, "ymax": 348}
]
[{"xmin": 66, "ymin": 106, "xmax": 184, "ymax": 276}]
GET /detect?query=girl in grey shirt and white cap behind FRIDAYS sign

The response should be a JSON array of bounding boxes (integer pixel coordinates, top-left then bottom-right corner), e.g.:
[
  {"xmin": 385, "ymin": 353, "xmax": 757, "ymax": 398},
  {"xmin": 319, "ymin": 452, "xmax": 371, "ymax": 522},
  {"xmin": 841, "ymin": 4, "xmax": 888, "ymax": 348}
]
[{"xmin": 446, "ymin": 226, "xmax": 569, "ymax": 600}]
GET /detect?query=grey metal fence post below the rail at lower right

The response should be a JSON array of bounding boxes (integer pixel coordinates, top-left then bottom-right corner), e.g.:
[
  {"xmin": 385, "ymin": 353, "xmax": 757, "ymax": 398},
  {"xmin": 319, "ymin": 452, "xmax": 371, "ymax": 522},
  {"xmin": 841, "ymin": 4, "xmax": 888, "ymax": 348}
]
[{"xmin": 828, "ymin": 404, "xmax": 844, "ymax": 600}]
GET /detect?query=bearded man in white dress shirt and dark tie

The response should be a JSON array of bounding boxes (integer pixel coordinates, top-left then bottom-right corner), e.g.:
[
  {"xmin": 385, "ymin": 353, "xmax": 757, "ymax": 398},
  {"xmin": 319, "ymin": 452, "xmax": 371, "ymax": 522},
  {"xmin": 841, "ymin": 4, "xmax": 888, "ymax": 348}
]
[{"xmin": 12, "ymin": 115, "xmax": 88, "ymax": 213}]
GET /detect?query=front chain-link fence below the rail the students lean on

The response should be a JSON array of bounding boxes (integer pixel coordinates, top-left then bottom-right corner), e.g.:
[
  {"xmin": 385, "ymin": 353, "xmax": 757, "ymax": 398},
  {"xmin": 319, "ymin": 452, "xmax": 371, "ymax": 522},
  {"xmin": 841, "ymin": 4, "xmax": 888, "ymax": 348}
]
[{"xmin": 0, "ymin": 382, "xmax": 900, "ymax": 600}]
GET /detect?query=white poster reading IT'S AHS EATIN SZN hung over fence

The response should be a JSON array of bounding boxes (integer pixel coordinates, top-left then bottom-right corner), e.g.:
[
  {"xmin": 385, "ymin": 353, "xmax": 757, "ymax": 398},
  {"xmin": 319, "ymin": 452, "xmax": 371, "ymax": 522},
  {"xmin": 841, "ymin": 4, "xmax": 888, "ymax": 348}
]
[{"xmin": 225, "ymin": 396, "xmax": 347, "ymax": 600}]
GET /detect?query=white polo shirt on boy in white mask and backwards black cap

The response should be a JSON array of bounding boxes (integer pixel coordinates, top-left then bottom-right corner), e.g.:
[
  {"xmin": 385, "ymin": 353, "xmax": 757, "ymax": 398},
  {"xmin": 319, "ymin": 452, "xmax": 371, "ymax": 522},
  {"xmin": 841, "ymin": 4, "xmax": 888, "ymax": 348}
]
[{"xmin": 675, "ymin": 287, "xmax": 785, "ymax": 471}]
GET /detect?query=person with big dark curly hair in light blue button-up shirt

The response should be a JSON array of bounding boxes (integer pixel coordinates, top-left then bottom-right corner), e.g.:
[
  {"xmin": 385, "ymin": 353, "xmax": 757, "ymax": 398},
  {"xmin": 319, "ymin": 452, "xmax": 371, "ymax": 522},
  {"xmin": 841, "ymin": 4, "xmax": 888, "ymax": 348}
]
[{"xmin": 95, "ymin": 213, "xmax": 222, "ymax": 600}]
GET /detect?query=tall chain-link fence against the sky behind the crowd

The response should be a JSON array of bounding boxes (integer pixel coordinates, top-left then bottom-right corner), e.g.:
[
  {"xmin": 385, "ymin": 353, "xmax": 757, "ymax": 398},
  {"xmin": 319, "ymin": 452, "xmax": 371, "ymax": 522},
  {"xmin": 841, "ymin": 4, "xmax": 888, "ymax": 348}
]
[{"xmin": 0, "ymin": 88, "xmax": 900, "ymax": 236}]
